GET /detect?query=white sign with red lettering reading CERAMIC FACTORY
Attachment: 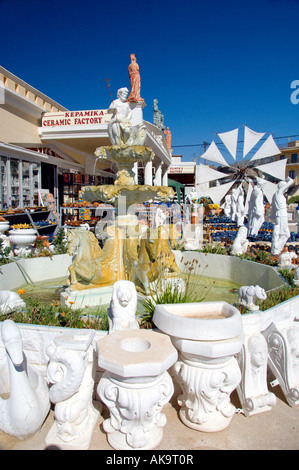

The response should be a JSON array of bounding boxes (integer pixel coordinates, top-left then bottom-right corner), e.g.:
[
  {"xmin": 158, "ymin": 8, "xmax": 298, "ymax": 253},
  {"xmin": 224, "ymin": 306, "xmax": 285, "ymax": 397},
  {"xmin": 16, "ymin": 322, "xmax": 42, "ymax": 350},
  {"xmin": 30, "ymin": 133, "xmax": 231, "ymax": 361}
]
[{"xmin": 42, "ymin": 109, "xmax": 111, "ymax": 127}]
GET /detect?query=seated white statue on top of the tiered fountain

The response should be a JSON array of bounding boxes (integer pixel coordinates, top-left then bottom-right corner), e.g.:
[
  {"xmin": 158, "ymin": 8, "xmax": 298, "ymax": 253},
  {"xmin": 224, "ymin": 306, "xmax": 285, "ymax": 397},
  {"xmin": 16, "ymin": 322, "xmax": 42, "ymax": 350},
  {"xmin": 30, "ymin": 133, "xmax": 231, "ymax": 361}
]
[{"xmin": 107, "ymin": 88, "xmax": 132, "ymax": 145}]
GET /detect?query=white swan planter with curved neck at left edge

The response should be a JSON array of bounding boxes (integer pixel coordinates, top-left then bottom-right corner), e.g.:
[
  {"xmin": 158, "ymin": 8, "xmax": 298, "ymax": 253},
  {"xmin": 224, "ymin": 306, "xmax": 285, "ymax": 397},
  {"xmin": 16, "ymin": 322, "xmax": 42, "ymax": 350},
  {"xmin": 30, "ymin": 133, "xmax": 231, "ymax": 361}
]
[{"xmin": 0, "ymin": 320, "xmax": 50, "ymax": 439}]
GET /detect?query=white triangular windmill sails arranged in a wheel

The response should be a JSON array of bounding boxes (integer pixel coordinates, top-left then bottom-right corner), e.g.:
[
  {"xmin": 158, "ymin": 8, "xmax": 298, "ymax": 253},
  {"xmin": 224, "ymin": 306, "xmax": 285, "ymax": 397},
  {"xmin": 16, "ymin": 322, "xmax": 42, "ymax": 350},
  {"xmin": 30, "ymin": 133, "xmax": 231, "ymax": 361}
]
[{"xmin": 196, "ymin": 125, "xmax": 286, "ymax": 204}]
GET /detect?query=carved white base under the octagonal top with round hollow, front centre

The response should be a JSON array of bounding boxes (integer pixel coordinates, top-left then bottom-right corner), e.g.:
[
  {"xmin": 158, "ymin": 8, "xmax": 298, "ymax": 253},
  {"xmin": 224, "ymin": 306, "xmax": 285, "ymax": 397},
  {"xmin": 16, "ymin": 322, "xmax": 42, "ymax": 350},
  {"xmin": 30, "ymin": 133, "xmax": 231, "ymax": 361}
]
[{"xmin": 98, "ymin": 372, "xmax": 173, "ymax": 450}]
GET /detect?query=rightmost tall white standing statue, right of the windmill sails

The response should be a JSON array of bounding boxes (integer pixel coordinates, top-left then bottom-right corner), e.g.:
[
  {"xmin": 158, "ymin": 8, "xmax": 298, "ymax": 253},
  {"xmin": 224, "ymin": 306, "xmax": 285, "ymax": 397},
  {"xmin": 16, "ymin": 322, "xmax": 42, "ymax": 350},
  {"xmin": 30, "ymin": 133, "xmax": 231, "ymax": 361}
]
[{"xmin": 271, "ymin": 177, "xmax": 294, "ymax": 255}]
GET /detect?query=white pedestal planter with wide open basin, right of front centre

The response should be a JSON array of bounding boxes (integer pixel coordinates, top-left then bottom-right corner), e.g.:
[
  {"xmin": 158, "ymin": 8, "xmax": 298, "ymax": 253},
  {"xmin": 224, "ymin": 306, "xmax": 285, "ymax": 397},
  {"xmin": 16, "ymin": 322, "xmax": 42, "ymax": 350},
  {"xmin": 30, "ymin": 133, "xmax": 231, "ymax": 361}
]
[{"xmin": 153, "ymin": 302, "xmax": 244, "ymax": 432}]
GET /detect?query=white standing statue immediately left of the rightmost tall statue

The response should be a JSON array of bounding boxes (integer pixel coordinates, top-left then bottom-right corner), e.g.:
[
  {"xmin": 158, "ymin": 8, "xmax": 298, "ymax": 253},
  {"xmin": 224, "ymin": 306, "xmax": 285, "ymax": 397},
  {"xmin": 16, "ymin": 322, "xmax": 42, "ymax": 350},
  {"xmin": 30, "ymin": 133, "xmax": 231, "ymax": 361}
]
[{"xmin": 248, "ymin": 180, "xmax": 265, "ymax": 237}]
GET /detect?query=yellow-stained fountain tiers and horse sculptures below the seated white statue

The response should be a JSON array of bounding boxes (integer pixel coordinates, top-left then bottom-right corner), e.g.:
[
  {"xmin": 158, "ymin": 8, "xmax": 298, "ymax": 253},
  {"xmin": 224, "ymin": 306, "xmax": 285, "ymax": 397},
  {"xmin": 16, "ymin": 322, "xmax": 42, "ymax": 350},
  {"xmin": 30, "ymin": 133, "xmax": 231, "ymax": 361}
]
[{"xmin": 64, "ymin": 140, "xmax": 179, "ymax": 304}]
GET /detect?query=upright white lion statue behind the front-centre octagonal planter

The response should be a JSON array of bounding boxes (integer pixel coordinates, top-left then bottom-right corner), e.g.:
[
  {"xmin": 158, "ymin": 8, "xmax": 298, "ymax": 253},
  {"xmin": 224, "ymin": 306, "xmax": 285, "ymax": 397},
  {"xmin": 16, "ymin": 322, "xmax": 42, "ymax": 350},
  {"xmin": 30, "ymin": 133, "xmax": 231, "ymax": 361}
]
[{"xmin": 108, "ymin": 280, "xmax": 139, "ymax": 333}]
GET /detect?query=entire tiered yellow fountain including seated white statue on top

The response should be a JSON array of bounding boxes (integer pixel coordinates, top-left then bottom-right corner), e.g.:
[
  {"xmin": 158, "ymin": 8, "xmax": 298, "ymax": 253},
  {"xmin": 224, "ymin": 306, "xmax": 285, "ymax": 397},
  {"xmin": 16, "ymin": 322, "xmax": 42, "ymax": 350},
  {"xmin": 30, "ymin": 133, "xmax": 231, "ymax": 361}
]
[{"xmin": 61, "ymin": 80, "xmax": 179, "ymax": 308}]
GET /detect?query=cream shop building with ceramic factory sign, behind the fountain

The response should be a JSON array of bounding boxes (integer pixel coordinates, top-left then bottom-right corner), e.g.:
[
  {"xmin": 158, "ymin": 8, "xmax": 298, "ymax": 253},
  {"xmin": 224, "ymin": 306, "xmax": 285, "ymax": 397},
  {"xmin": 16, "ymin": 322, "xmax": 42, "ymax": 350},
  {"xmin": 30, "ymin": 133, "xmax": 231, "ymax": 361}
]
[{"xmin": 0, "ymin": 67, "xmax": 171, "ymax": 210}]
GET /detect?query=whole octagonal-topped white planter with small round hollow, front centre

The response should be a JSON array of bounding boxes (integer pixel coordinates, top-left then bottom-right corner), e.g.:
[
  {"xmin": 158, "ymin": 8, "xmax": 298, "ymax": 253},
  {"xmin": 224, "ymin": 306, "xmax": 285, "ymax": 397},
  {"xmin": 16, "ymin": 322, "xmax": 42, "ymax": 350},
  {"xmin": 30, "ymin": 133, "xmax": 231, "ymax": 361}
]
[{"xmin": 97, "ymin": 330, "xmax": 177, "ymax": 450}]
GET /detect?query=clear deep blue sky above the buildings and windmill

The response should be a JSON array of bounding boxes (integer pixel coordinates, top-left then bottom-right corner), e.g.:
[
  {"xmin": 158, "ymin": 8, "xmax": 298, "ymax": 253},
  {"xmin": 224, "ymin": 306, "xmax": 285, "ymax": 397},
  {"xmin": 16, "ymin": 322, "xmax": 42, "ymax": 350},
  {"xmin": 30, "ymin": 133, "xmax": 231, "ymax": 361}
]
[{"xmin": 0, "ymin": 0, "xmax": 299, "ymax": 161}]
